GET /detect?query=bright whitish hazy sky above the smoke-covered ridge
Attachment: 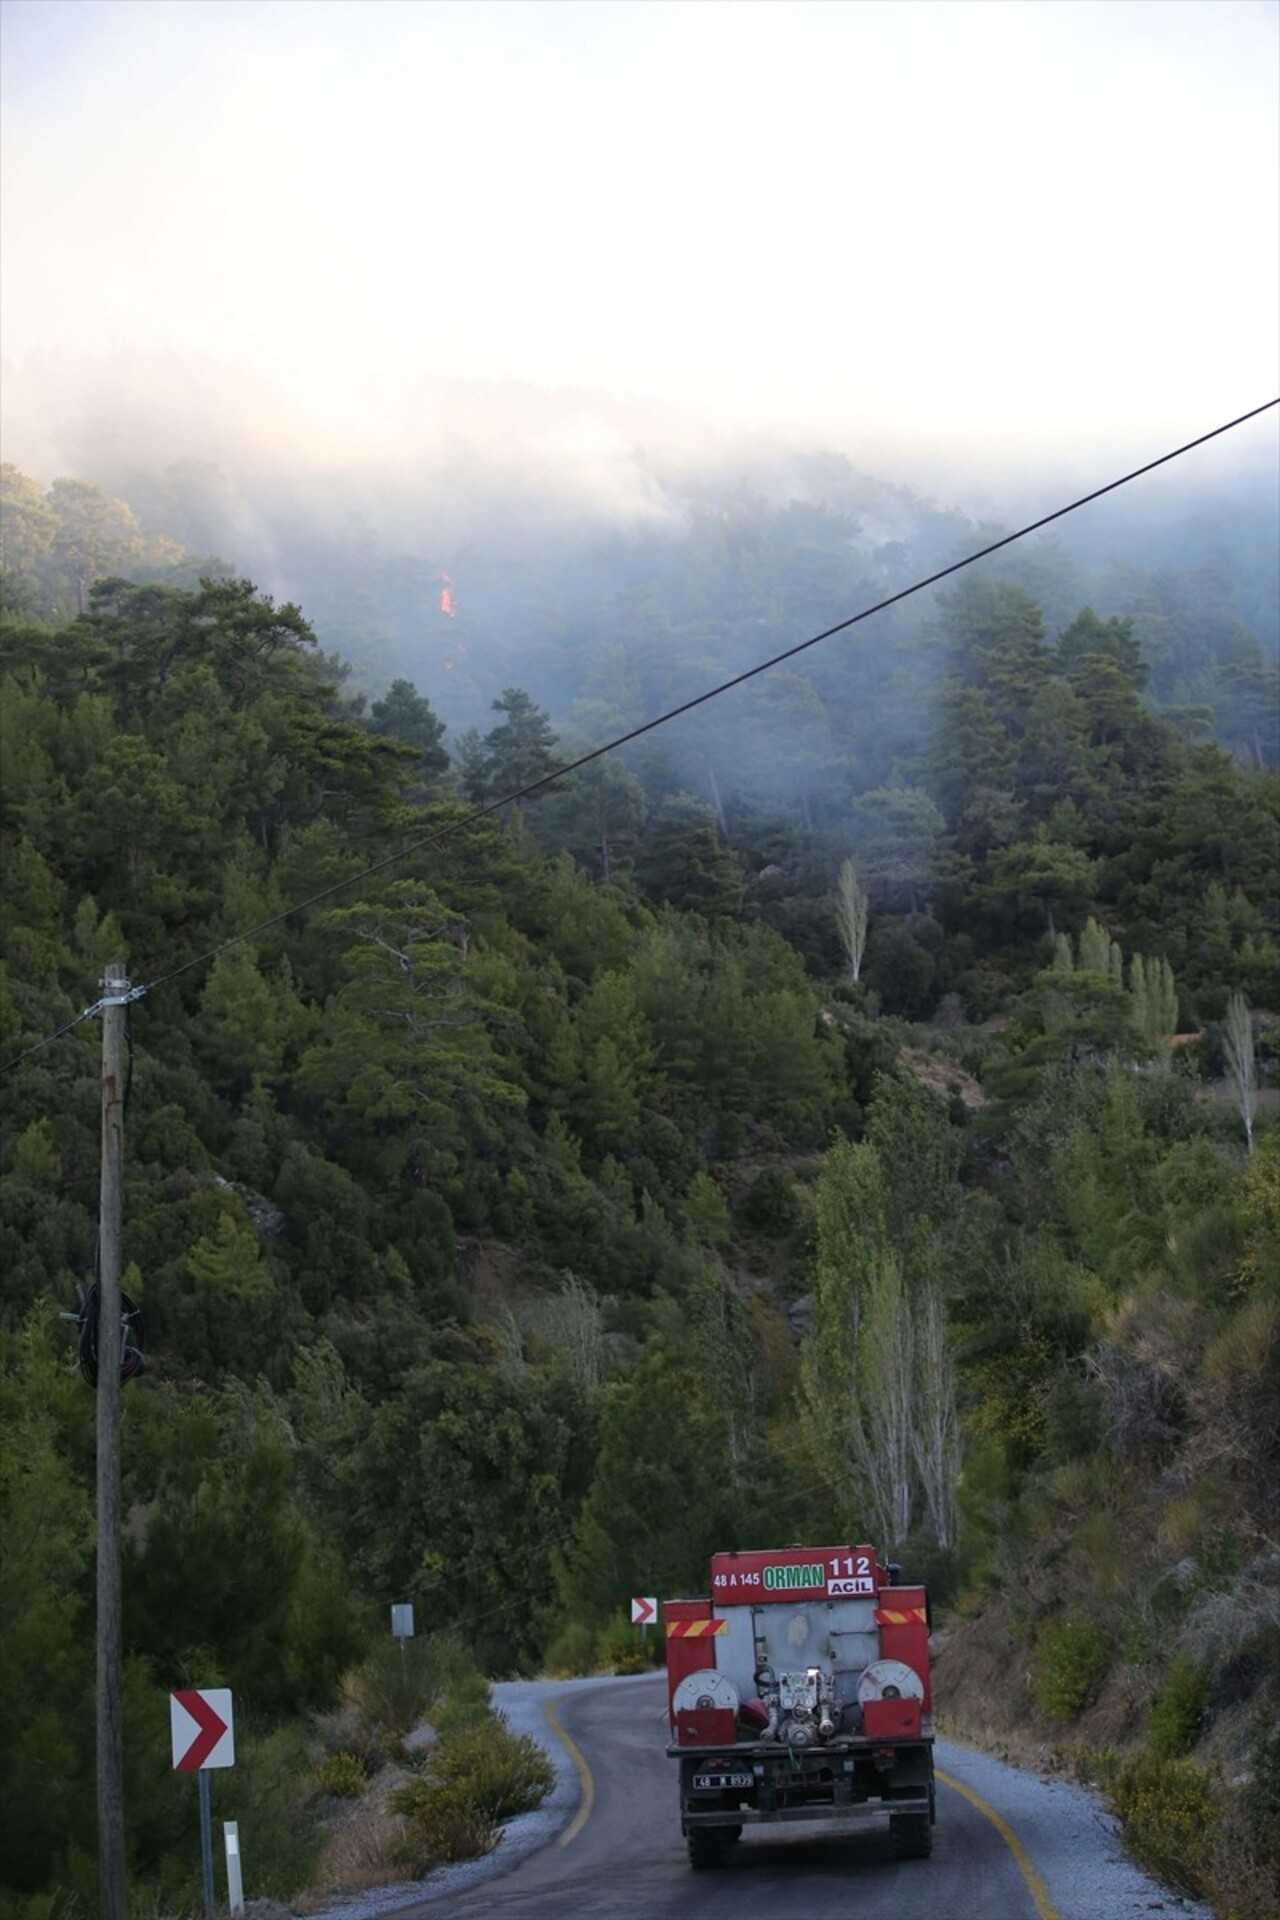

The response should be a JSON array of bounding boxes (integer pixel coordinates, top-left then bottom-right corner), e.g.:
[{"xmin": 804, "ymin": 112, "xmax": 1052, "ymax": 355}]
[{"xmin": 0, "ymin": 0, "xmax": 1280, "ymax": 476}]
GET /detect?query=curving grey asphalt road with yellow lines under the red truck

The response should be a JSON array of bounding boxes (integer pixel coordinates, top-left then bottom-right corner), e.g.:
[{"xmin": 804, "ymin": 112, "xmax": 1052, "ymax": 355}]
[{"xmin": 370, "ymin": 1676, "xmax": 1203, "ymax": 1920}]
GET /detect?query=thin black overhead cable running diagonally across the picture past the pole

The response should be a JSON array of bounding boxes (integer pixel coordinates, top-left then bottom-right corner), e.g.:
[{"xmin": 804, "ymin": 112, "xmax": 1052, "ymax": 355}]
[{"xmin": 0, "ymin": 397, "xmax": 1280, "ymax": 1073}]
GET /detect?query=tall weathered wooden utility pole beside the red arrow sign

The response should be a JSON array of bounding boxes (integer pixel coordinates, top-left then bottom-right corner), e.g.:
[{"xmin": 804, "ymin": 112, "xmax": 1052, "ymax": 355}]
[{"xmin": 98, "ymin": 962, "xmax": 129, "ymax": 1920}]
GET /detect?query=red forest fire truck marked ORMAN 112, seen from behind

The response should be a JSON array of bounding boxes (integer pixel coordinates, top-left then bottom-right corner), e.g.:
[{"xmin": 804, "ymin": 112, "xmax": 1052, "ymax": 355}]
[{"xmin": 662, "ymin": 1546, "xmax": 935, "ymax": 1866}]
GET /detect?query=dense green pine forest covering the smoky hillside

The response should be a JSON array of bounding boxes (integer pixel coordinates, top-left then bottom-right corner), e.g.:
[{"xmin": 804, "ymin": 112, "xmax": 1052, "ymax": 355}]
[{"xmin": 0, "ymin": 468, "xmax": 1280, "ymax": 1920}]
